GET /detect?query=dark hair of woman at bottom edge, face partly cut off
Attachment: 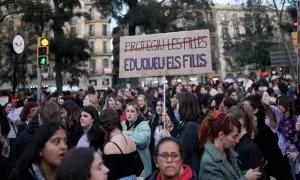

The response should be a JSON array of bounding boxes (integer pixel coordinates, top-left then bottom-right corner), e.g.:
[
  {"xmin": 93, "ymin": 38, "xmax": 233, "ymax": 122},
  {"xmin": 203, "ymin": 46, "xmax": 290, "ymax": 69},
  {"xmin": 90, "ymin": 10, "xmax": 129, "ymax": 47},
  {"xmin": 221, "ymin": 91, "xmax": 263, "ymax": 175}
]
[{"xmin": 55, "ymin": 148, "xmax": 95, "ymax": 180}]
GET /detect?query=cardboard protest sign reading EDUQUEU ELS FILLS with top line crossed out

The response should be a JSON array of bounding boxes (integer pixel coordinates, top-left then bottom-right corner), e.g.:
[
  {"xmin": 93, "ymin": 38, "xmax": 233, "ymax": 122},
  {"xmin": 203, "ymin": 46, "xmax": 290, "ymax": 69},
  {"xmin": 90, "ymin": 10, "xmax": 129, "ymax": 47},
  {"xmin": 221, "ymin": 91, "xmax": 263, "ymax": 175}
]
[{"xmin": 119, "ymin": 30, "xmax": 212, "ymax": 78}]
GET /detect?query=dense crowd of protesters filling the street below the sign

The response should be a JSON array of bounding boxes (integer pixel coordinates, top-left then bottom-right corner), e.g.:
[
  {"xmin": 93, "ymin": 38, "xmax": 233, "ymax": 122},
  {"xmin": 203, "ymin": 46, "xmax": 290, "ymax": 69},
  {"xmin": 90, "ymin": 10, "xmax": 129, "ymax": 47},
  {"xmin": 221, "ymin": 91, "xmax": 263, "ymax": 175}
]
[{"xmin": 0, "ymin": 75, "xmax": 300, "ymax": 180}]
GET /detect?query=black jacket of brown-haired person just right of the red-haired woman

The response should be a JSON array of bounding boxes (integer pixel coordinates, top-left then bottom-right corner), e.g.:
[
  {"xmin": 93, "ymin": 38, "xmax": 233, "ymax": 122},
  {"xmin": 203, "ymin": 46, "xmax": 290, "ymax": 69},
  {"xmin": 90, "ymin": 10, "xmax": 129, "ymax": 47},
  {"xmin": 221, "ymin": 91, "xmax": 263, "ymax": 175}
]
[{"xmin": 235, "ymin": 133, "xmax": 263, "ymax": 171}]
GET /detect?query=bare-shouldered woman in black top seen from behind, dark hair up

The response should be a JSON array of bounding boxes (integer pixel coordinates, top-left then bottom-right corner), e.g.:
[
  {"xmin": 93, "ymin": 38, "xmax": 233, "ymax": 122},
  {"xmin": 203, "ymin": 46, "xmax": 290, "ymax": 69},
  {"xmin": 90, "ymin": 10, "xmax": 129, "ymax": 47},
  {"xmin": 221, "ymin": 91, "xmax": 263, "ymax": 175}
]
[{"xmin": 100, "ymin": 109, "xmax": 138, "ymax": 180}]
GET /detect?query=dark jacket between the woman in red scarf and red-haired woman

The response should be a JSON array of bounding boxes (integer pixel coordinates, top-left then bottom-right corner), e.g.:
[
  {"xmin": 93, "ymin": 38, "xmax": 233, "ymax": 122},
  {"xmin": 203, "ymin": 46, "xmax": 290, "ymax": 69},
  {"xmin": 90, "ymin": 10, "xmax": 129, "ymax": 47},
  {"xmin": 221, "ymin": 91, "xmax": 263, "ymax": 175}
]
[{"xmin": 177, "ymin": 122, "xmax": 200, "ymax": 174}]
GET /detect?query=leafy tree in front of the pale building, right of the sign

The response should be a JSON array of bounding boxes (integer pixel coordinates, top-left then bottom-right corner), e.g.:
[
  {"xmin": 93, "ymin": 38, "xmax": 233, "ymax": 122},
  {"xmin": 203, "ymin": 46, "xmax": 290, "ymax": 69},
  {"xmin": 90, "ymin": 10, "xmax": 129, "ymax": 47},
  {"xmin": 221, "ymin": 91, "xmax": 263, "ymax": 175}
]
[{"xmin": 233, "ymin": 0, "xmax": 278, "ymax": 69}]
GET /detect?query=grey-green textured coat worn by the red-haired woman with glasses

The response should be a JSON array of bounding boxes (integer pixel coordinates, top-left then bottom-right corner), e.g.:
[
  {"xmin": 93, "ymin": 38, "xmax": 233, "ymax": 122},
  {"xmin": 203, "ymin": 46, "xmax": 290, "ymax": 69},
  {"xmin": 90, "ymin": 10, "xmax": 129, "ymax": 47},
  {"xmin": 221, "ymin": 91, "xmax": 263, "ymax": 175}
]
[{"xmin": 198, "ymin": 141, "xmax": 246, "ymax": 180}]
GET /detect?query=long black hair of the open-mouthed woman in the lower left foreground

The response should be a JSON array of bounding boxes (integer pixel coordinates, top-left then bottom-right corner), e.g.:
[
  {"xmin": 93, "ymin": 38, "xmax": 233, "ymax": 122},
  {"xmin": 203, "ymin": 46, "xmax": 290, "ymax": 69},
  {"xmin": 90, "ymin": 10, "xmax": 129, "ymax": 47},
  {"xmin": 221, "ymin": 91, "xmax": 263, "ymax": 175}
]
[{"xmin": 11, "ymin": 123, "xmax": 65, "ymax": 179}]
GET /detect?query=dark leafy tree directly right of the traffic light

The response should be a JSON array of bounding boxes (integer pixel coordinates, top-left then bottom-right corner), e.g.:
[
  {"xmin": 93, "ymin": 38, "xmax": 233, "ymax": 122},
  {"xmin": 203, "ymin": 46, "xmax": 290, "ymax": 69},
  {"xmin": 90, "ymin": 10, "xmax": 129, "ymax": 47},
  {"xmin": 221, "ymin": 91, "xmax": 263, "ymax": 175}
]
[{"xmin": 23, "ymin": 0, "xmax": 89, "ymax": 92}]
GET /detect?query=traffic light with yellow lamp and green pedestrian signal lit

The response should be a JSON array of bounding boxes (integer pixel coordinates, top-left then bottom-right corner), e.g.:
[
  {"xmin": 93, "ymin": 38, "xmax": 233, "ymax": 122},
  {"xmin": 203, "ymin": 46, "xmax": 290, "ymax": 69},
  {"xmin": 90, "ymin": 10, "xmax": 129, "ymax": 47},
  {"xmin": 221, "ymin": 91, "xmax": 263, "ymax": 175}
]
[{"xmin": 36, "ymin": 37, "xmax": 50, "ymax": 66}]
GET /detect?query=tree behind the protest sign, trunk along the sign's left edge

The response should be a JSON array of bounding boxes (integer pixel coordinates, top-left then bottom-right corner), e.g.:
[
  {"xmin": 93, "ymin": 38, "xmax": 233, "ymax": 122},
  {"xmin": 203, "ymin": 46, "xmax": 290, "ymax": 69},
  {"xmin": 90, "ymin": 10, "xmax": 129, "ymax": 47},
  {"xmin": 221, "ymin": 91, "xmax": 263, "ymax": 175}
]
[{"xmin": 95, "ymin": 0, "xmax": 214, "ymax": 85}]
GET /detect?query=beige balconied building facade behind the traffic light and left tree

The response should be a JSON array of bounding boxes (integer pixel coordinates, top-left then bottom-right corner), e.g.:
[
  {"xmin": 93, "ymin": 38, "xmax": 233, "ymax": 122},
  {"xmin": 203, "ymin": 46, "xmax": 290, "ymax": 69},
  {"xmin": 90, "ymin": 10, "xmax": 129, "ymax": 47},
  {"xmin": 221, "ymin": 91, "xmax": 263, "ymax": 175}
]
[{"xmin": 0, "ymin": 0, "xmax": 112, "ymax": 91}]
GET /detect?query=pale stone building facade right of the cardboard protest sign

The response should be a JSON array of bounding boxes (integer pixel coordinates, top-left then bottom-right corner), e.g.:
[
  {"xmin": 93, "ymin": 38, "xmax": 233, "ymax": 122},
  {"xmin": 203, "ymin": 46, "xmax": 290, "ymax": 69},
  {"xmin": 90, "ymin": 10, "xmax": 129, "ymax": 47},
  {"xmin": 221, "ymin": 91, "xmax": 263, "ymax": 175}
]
[{"xmin": 213, "ymin": 4, "xmax": 288, "ymax": 80}]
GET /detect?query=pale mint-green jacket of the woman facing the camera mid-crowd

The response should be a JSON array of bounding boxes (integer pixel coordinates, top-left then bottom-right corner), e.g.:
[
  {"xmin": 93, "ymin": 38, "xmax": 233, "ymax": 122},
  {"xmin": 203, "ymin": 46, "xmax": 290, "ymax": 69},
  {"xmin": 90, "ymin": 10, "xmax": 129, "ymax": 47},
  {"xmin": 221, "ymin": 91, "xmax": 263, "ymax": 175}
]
[{"xmin": 122, "ymin": 120, "xmax": 152, "ymax": 178}]
